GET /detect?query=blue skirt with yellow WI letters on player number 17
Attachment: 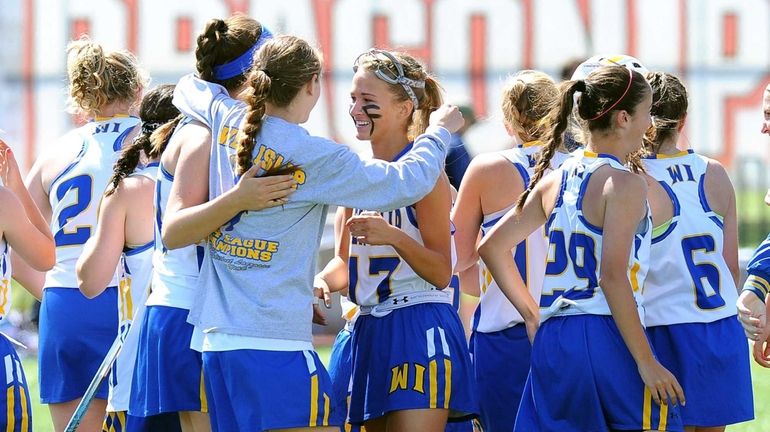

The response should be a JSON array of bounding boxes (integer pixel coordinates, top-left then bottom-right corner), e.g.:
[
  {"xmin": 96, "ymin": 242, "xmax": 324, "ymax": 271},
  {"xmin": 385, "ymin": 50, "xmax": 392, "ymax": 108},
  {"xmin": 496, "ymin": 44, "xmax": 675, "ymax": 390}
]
[{"xmin": 348, "ymin": 303, "xmax": 478, "ymax": 424}]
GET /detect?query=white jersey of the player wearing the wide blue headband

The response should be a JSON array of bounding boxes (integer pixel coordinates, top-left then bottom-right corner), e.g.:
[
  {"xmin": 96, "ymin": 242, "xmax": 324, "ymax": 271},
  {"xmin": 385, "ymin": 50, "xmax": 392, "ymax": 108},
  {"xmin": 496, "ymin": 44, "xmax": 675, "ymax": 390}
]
[{"xmin": 147, "ymin": 118, "xmax": 203, "ymax": 310}]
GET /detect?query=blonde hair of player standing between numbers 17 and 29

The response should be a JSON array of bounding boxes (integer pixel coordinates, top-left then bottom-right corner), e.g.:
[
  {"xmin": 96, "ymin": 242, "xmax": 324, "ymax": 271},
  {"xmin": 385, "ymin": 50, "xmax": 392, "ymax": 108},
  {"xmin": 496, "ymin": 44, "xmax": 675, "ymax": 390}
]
[{"xmin": 502, "ymin": 70, "xmax": 559, "ymax": 142}]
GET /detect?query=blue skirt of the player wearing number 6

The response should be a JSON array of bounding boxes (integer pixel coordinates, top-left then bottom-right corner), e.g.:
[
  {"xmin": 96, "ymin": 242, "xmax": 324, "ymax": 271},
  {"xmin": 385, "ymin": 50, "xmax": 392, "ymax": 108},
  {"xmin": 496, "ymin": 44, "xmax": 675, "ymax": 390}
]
[{"xmin": 647, "ymin": 316, "xmax": 754, "ymax": 427}]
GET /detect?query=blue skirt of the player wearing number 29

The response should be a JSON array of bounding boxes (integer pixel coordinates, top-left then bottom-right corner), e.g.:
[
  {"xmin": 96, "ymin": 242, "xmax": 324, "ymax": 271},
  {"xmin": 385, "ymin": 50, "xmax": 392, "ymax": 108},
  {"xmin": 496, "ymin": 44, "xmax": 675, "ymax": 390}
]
[{"xmin": 514, "ymin": 315, "xmax": 686, "ymax": 432}]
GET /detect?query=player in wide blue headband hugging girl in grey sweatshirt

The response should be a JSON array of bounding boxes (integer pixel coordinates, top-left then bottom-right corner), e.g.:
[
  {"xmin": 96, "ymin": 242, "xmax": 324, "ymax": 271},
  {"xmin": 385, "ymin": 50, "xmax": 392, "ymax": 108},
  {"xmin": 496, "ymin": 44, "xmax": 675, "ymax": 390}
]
[{"xmin": 129, "ymin": 15, "xmax": 290, "ymax": 431}]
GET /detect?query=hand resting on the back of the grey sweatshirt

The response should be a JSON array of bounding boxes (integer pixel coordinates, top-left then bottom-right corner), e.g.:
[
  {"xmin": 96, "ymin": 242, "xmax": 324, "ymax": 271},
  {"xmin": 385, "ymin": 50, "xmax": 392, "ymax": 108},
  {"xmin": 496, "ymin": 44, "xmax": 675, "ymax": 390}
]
[{"xmin": 233, "ymin": 165, "xmax": 297, "ymax": 211}]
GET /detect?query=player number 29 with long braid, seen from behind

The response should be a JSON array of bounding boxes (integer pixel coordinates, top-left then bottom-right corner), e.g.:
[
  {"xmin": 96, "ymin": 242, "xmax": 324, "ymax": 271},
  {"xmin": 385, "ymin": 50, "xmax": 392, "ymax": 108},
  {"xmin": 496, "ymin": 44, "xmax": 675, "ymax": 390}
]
[{"xmin": 479, "ymin": 66, "xmax": 684, "ymax": 431}]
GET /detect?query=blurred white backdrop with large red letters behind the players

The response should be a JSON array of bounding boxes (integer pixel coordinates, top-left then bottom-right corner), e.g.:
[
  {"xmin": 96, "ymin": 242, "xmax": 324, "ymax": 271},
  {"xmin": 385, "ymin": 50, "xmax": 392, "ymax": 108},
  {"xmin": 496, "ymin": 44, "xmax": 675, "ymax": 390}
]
[{"xmin": 0, "ymin": 0, "xmax": 770, "ymax": 430}]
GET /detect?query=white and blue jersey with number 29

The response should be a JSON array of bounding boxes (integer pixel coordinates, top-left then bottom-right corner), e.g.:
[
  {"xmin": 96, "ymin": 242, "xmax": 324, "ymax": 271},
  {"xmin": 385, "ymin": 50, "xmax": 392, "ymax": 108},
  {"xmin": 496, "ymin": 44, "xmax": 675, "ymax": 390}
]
[{"xmin": 540, "ymin": 150, "xmax": 652, "ymax": 323}]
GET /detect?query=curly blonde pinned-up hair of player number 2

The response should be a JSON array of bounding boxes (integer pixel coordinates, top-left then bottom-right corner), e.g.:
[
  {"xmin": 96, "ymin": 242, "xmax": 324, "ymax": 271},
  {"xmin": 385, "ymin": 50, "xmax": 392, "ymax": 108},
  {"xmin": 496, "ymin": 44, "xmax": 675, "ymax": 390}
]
[{"xmin": 67, "ymin": 37, "xmax": 149, "ymax": 115}]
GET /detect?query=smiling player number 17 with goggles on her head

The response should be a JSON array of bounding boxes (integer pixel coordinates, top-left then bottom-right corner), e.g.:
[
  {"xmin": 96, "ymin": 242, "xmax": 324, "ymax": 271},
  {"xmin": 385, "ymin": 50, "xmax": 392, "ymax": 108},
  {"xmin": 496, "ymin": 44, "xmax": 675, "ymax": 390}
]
[{"xmin": 314, "ymin": 50, "xmax": 476, "ymax": 431}]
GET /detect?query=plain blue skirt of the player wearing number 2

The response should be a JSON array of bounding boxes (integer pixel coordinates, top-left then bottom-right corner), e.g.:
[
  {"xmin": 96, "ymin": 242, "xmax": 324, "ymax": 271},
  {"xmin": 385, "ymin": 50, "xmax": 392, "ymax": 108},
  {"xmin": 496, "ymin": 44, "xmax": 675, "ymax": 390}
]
[{"xmin": 38, "ymin": 287, "xmax": 118, "ymax": 404}]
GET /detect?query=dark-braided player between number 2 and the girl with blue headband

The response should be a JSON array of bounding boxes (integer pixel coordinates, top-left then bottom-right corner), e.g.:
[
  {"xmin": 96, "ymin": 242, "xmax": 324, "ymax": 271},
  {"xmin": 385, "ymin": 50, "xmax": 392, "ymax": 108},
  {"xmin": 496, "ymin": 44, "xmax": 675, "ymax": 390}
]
[{"xmin": 77, "ymin": 85, "xmax": 179, "ymax": 431}]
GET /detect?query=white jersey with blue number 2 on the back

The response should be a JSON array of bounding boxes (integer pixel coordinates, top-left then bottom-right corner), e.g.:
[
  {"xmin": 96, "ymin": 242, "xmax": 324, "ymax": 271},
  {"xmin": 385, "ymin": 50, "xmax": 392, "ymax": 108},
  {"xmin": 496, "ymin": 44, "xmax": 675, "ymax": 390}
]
[{"xmin": 44, "ymin": 117, "xmax": 140, "ymax": 289}]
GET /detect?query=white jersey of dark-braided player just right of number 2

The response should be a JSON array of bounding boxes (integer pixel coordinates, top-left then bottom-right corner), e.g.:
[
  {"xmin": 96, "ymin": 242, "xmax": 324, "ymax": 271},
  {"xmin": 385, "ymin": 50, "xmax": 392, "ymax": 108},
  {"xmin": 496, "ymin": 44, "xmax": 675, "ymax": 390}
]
[{"xmin": 107, "ymin": 164, "xmax": 158, "ymax": 412}]
